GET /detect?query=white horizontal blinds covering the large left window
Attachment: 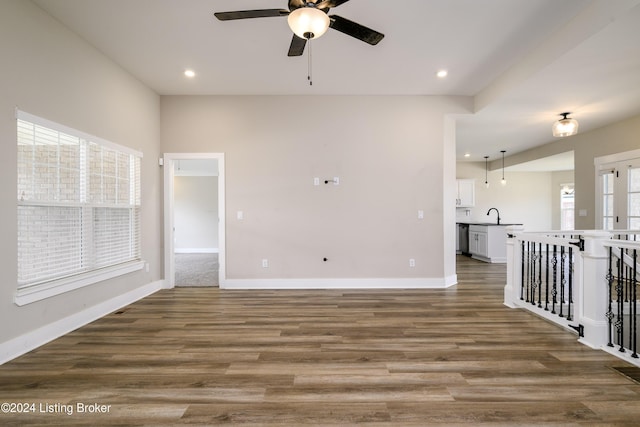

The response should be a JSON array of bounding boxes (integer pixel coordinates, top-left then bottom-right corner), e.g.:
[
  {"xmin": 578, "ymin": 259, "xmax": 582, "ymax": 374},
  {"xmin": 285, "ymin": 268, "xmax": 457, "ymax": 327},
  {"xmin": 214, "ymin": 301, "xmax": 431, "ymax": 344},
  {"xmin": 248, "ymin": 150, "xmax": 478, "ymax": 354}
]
[{"xmin": 17, "ymin": 111, "xmax": 141, "ymax": 289}]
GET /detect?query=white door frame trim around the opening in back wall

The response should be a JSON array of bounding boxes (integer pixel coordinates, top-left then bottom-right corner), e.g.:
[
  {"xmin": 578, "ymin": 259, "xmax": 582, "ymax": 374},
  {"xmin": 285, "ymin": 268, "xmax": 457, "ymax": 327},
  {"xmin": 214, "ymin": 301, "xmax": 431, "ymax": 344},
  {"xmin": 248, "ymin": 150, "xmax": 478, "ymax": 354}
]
[{"xmin": 163, "ymin": 153, "xmax": 226, "ymax": 288}]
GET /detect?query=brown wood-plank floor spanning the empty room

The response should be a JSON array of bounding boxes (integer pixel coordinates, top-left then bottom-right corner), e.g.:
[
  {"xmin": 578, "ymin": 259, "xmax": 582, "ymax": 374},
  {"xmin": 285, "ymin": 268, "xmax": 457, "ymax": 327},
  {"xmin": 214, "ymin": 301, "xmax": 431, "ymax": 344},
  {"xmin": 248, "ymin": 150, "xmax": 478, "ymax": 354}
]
[{"xmin": 0, "ymin": 257, "xmax": 640, "ymax": 426}]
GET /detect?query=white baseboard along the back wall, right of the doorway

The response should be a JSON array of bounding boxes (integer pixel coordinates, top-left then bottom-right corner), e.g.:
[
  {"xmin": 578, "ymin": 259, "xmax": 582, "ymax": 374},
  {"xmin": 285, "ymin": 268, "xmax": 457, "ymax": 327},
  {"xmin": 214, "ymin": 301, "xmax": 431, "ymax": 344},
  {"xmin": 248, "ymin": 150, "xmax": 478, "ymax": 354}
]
[{"xmin": 220, "ymin": 274, "xmax": 458, "ymax": 289}]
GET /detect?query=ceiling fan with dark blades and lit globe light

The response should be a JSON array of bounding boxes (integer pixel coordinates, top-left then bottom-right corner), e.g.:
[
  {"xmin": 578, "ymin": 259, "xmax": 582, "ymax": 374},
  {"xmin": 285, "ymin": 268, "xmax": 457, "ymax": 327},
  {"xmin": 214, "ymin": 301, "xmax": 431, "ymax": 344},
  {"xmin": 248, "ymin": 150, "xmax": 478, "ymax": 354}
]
[{"xmin": 214, "ymin": 0, "xmax": 384, "ymax": 56}]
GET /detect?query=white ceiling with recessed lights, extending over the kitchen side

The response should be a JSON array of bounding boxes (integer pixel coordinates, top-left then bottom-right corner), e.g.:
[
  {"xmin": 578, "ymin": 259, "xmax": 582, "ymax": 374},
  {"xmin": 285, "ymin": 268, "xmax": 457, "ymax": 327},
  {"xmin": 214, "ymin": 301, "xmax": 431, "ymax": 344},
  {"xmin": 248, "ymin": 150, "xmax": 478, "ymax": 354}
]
[{"xmin": 33, "ymin": 0, "xmax": 640, "ymax": 171}]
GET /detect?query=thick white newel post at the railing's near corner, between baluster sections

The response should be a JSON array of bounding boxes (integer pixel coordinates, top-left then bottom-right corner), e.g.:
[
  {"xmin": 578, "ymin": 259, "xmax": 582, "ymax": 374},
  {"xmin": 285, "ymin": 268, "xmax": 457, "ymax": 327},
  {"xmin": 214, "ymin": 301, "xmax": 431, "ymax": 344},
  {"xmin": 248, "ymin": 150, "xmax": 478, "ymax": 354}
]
[{"xmin": 577, "ymin": 230, "xmax": 611, "ymax": 348}]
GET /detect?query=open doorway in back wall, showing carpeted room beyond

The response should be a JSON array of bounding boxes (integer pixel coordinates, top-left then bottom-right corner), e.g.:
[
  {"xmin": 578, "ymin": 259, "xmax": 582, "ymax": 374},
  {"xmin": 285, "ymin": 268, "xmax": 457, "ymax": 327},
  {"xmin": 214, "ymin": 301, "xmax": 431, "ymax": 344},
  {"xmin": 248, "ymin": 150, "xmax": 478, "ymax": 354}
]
[{"xmin": 163, "ymin": 153, "xmax": 225, "ymax": 288}]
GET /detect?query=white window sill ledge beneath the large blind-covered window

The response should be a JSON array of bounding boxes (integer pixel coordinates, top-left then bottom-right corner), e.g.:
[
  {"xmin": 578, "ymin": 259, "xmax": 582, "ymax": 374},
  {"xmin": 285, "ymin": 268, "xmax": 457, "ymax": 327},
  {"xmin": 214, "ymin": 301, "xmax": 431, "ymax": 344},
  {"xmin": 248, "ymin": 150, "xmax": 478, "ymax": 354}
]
[{"xmin": 14, "ymin": 261, "xmax": 144, "ymax": 306}]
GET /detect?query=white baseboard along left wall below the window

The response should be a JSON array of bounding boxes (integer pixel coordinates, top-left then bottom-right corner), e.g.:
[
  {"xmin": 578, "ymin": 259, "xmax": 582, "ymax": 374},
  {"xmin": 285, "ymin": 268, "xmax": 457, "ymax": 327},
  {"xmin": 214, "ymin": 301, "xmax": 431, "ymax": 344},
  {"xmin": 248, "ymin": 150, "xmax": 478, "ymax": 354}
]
[{"xmin": 0, "ymin": 280, "xmax": 164, "ymax": 365}]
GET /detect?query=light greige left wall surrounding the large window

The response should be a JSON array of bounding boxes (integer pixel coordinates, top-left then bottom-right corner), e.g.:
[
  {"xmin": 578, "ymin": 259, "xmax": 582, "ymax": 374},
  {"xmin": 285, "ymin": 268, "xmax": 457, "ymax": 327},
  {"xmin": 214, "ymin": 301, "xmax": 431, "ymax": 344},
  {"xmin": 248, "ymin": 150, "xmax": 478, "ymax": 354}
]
[{"xmin": 0, "ymin": 1, "xmax": 162, "ymax": 343}]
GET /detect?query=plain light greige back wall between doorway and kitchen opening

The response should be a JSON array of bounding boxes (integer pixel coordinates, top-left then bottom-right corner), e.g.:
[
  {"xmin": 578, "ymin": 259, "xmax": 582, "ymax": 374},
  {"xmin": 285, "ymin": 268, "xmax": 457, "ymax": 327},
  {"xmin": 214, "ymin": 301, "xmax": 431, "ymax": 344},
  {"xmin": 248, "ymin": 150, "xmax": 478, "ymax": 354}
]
[{"xmin": 161, "ymin": 96, "xmax": 470, "ymax": 279}]
